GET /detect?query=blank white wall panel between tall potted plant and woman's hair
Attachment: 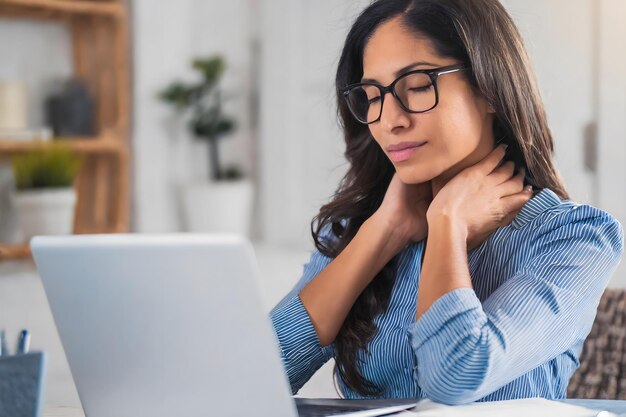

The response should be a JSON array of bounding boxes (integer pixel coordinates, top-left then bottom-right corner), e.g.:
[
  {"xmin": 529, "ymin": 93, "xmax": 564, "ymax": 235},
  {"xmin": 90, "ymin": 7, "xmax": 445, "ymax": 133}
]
[{"xmin": 260, "ymin": 0, "xmax": 369, "ymax": 246}]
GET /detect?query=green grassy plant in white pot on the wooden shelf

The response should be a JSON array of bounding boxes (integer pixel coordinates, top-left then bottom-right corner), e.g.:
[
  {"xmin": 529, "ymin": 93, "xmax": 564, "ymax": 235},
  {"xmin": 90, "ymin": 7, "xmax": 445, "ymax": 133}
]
[{"xmin": 11, "ymin": 144, "xmax": 82, "ymax": 240}]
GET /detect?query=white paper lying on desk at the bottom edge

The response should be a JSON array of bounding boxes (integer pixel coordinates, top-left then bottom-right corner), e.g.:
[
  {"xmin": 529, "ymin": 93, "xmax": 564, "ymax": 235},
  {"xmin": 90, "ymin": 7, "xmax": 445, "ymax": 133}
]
[{"xmin": 394, "ymin": 398, "xmax": 616, "ymax": 417}]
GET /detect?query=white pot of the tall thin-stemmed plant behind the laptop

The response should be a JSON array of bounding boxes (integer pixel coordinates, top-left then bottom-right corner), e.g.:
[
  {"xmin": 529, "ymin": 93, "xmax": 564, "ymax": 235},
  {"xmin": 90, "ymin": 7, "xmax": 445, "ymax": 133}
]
[{"xmin": 182, "ymin": 180, "xmax": 254, "ymax": 237}]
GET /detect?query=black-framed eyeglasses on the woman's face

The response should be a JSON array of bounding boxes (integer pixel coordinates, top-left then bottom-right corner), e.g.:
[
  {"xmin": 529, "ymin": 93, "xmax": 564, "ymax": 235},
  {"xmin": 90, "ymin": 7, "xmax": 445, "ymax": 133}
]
[{"xmin": 341, "ymin": 64, "xmax": 467, "ymax": 124}]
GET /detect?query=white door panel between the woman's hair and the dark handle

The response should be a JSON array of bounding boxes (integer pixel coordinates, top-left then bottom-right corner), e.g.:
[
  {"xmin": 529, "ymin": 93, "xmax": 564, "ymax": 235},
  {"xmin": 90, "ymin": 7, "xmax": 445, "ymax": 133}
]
[{"xmin": 502, "ymin": 0, "xmax": 597, "ymax": 204}]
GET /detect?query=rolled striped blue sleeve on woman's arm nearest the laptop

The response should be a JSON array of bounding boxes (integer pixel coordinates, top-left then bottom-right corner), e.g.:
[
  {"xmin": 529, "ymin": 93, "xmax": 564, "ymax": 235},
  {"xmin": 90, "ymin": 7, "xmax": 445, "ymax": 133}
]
[{"xmin": 270, "ymin": 247, "xmax": 334, "ymax": 394}]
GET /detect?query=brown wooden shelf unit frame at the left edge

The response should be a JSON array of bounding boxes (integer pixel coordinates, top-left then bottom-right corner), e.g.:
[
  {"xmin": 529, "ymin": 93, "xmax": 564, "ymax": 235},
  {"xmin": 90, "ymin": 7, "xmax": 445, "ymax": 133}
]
[{"xmin": 0, "ymin": 0, "xmax": 131, "ymax": 260}]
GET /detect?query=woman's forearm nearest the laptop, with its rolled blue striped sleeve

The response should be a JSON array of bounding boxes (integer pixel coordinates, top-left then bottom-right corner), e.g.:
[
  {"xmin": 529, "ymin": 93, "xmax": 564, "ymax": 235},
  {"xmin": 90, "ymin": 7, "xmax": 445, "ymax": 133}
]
[{"xmin": 271, "ymin": 216, "xmax": 401, "ymax": 393}]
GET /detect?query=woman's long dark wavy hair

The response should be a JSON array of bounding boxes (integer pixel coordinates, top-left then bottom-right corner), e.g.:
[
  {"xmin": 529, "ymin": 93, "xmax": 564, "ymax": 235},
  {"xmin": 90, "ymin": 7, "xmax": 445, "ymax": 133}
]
[{"xmin": 311, "ymin": 0, "xmax": 569, "ymax": 396}]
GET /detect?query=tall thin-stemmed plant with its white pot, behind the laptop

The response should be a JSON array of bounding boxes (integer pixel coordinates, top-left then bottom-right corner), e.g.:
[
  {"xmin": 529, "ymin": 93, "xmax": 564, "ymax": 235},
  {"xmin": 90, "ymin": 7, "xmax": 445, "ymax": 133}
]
[{"xmin": 159, "ymin": 55, "xmax": 253, "ymax": 235}]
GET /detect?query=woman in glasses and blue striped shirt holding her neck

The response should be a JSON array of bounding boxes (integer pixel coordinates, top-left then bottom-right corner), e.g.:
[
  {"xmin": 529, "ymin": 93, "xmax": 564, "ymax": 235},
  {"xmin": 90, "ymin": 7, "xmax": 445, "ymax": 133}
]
[{"xmin": 271, "ymin": 0, "xmax": 623, "ymax": 404}]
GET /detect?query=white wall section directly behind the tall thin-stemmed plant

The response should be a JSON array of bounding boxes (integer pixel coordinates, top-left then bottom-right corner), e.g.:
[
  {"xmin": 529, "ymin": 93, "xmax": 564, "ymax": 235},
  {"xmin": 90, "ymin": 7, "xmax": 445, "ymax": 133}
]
[{"xmin": 133, "ymin": 0, "xmax": 256, "ymax": 232}]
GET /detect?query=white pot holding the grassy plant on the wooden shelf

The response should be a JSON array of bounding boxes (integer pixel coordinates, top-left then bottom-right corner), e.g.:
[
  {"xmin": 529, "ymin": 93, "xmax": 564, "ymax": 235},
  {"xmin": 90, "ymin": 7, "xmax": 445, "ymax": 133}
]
[{"xmin": 13, "ymin": 188, "xmax": 76, "ymax": 241}]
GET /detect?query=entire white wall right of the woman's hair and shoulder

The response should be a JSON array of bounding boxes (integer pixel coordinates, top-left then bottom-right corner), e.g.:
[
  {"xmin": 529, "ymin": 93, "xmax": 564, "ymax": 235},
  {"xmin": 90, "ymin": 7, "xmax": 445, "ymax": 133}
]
[{"xmin": 503, "ymin": 0, "xmax": 626, "ymax": 287}]
